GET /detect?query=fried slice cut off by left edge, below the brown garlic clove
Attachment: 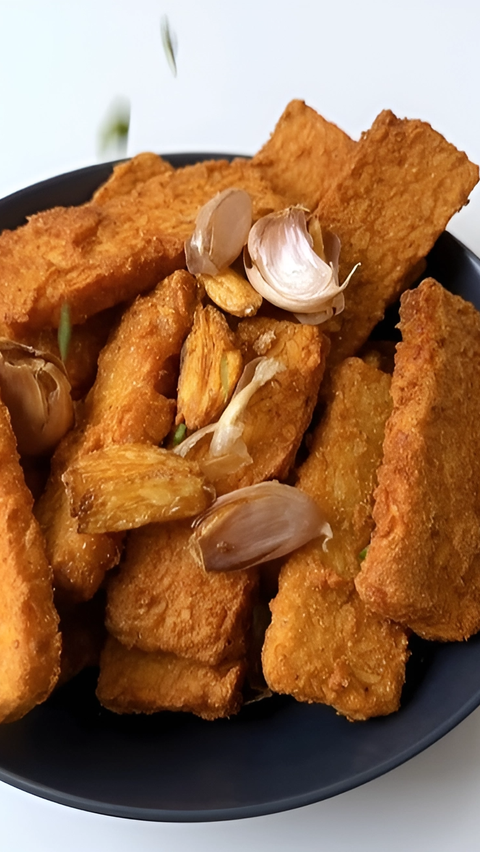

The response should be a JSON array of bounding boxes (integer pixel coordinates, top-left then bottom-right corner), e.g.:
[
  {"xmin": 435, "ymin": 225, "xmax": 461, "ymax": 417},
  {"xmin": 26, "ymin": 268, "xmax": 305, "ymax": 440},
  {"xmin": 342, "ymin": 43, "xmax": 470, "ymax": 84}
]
[{"xmin": 0, "ymin": 392, "xmax": 61, "ymax": 722}]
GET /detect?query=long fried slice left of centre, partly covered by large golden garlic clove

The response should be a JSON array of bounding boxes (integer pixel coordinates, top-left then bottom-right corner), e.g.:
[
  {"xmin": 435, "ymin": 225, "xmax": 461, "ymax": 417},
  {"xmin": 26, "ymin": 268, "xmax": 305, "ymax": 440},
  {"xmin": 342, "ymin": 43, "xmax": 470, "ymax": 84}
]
[{"xmin": 36, "ymin": 270, "xmax": 197, "ymax": 600}]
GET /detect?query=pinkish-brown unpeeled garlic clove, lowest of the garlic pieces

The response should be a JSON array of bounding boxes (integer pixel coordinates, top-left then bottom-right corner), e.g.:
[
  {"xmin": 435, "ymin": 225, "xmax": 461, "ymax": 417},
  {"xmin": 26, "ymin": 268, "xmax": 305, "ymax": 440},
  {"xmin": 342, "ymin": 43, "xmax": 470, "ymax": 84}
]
[{"xmin": 192, "ymin": 481, "xmax": 332, "ymax": 571}]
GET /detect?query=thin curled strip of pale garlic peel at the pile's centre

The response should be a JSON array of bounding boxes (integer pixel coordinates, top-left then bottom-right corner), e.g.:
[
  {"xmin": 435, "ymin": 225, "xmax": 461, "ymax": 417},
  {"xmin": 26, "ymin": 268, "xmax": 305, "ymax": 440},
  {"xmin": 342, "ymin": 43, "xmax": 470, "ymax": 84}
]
[{"xmin": 173, "ymin": 357, "xmax": 285, "ymax": 481}]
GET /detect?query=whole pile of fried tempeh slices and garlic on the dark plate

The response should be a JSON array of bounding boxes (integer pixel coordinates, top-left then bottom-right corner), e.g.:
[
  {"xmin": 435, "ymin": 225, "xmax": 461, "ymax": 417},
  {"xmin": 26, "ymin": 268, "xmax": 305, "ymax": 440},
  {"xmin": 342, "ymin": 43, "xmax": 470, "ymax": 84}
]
[{"xmin": 0, "ymin": 101, "xmax": 480, "ymax": 721}]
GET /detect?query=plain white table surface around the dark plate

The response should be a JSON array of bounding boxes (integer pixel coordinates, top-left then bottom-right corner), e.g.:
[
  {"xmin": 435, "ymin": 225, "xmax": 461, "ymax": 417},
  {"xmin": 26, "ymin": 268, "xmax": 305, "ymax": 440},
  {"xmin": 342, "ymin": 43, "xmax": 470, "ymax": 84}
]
[{"xmin": 0, "ymin": 0, "xmax": 480, "ymax": 852}]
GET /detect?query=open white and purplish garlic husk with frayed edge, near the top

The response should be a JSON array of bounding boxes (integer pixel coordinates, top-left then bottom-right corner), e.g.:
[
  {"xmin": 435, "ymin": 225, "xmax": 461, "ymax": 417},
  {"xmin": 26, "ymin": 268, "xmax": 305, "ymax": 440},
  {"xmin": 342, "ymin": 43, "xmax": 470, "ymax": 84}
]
[{"xmin": 244, "ymin": 207, "xmax": 353, "ymax": 325}]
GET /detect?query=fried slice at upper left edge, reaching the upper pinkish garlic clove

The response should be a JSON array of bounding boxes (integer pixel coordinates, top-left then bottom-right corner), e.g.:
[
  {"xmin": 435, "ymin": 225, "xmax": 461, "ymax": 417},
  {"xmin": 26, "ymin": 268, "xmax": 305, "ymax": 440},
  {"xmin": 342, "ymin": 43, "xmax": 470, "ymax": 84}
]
[{"xmin": 0, "ymin": 204, "xmax": 184, "ymax": 333}]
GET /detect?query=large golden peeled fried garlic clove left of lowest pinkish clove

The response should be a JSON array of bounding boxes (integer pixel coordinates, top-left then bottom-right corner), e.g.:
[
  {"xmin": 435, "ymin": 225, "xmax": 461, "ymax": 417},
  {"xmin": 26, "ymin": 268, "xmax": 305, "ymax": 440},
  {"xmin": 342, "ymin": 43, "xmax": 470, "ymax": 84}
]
[{"xmin": 62, "ymin": 444, "xmax": 215, "ymax": 533}]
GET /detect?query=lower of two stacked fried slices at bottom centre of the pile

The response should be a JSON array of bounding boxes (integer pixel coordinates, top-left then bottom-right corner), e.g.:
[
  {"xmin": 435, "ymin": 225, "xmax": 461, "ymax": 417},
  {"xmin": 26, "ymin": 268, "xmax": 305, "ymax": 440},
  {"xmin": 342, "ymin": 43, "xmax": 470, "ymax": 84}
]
[{"xmin": 97, "ymin": 637, "xmax": 245, "ymax": 720}]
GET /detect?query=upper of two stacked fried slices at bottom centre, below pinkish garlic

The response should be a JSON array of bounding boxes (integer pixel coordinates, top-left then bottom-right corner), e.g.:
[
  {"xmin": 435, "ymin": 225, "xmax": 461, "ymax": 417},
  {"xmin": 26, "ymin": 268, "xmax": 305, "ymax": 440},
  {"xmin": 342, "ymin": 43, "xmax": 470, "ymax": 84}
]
[{"xmin": 106, "ymin": 521, "xmax": 258, "ymax": 665}]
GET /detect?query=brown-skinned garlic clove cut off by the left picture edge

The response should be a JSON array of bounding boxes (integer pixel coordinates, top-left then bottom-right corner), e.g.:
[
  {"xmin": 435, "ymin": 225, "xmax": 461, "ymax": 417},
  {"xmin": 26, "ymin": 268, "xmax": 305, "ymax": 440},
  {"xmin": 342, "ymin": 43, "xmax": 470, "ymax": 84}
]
[{"xmin": 0, "ymin": 338, "xmax": 74, "ymax": 456}]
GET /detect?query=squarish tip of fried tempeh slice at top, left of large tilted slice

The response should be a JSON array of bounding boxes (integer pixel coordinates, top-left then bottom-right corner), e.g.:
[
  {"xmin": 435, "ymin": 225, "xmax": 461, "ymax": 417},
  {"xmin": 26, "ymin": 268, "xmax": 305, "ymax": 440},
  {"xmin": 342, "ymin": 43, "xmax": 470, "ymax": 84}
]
[{"xmin": 253, "ymin": 100, "xmax": 355, "ymax": 210}]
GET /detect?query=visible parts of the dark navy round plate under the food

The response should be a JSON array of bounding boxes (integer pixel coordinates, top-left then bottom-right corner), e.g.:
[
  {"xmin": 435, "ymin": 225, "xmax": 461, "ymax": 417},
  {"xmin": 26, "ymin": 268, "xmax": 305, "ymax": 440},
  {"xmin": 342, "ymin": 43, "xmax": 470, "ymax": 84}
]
[{"xmin": 0, "ymin": 155, "xmax": 480, "ymax": 822}]
